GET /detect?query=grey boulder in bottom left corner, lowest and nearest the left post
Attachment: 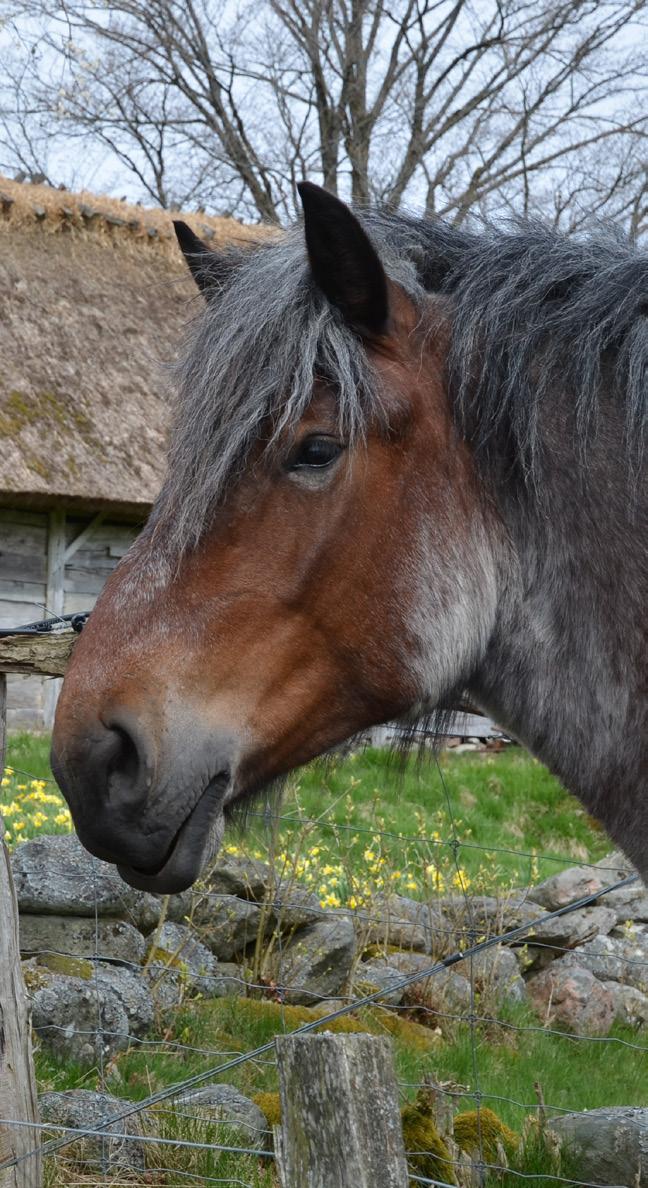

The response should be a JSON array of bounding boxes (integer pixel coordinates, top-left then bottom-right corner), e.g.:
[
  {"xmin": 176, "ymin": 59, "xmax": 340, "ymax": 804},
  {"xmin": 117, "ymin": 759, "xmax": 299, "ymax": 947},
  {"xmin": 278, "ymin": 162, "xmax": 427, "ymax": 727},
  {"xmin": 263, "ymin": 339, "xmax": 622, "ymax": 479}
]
[{"xmin": 38, "ymin": 1089, "xmax": 145, "ymax": 1180}]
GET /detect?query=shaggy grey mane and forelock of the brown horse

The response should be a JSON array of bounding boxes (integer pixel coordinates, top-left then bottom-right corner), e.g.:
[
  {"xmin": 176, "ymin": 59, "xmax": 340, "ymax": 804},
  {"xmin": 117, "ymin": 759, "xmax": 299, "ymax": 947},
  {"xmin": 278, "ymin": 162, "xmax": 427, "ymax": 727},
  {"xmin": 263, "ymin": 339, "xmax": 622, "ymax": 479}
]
[{"xmin": 155, "ymin": 213, "xmax": 648, "ymax": 549}]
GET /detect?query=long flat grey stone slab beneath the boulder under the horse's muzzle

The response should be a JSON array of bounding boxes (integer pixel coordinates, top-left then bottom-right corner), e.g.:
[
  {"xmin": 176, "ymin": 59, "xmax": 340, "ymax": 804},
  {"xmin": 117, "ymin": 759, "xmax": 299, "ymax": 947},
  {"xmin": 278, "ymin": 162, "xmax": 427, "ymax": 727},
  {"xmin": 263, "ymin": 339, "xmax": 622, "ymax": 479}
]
[{"xmin": 19, "ymin": 915, "xmax": 146, "ymax": 965}]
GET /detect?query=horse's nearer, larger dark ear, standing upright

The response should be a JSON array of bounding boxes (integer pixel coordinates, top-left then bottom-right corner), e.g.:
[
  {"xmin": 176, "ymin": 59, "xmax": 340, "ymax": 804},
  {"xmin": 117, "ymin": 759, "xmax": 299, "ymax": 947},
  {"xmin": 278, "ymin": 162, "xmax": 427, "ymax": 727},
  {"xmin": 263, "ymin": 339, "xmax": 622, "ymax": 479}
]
[{"xmin": 297, "ymin": 182, "xmax": 389, "ymax": 334}]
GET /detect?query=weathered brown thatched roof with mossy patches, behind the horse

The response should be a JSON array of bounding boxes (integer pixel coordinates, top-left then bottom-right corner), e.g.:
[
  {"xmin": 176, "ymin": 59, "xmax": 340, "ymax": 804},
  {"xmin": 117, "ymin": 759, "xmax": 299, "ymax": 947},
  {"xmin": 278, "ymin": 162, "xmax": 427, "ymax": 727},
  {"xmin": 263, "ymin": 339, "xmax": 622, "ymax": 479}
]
[{"xmin": 0, "ymin": 177, "xmax": 263, "ymax": 512}]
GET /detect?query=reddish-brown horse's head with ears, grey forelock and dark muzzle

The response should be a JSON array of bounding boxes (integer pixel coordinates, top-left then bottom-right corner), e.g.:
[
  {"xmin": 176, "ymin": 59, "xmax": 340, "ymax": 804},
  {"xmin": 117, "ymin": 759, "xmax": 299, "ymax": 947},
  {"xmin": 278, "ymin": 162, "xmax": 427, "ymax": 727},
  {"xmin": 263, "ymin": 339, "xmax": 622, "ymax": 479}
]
[{"xmin": 52, "ymin": 183, "xmax": 498, "ymax": 892}]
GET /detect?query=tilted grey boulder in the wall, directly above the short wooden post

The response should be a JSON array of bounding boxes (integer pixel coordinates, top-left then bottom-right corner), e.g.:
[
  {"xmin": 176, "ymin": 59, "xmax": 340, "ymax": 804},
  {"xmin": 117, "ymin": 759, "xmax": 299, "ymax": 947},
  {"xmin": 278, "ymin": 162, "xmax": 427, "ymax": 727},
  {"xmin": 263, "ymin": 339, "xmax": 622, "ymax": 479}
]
[{"xmin": 268, "ymin": 912, "xmax": 356, "ymax": 1006}]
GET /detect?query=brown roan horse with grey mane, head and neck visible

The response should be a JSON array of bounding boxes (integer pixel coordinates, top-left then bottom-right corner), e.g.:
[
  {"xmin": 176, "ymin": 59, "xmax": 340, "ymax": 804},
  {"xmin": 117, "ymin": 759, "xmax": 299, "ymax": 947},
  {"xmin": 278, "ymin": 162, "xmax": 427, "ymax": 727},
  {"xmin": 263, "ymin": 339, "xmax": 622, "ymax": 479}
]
[{"xmin": 52, "ymin": 182, "xmax": 648, "ymax": 892}]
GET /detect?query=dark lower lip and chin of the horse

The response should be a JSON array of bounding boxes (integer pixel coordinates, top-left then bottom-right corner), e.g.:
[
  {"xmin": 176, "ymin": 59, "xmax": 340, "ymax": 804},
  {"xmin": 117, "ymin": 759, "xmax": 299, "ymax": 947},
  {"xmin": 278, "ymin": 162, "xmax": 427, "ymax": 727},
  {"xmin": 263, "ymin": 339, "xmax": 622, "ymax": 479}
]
[{"xmin": 117, "ymin": 773, "xmax": 229, "ymax": 895}]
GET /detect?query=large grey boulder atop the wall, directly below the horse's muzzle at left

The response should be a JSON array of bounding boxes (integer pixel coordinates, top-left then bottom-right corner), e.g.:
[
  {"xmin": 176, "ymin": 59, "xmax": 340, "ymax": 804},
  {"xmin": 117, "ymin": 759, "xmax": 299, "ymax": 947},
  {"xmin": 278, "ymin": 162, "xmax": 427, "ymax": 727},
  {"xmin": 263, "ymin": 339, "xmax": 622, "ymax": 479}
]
[{"xmin": 12, "ymin": 833, "xmax": 161, "ymax": 930}]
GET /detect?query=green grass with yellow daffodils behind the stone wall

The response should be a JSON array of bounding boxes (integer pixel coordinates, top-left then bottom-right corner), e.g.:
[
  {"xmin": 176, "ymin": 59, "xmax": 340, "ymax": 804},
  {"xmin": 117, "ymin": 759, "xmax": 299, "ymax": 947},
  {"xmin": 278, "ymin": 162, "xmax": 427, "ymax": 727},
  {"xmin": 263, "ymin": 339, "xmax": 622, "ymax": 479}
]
[{"xmin": 0, "ymin": 733, "xmax": 611, "ymax": 906}]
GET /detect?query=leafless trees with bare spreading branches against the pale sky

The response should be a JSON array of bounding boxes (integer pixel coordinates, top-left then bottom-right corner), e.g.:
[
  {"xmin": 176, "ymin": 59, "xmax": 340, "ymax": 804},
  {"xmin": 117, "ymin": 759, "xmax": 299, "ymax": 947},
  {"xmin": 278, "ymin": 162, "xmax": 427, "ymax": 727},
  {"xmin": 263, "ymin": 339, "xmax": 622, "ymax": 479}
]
[{"xmin": 1, "ymin": 0, "xmax": 648, "ymax": 234}]
